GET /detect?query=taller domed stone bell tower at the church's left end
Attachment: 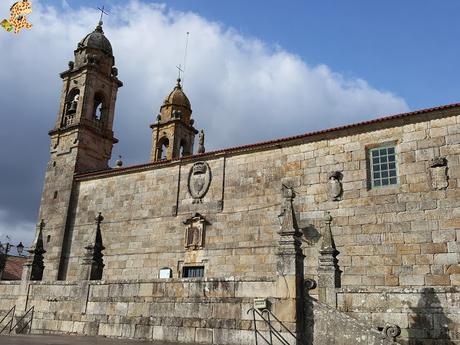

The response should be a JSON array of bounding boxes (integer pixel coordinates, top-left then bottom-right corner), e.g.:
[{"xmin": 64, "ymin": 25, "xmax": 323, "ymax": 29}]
[{"xmin": 33, "ymin": 21, "xmax": 123, "ymax": 280}]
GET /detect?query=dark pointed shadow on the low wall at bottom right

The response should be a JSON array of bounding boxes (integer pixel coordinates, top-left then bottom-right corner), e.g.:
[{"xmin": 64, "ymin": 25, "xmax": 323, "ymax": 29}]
[{"xmin": 407, "ymin": 288, "xmax": 459, "ymax": 345}]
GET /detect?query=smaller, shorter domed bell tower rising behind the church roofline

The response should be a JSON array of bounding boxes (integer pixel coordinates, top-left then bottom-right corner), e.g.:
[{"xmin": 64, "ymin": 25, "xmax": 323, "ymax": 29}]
[{"xmin": 150, "ymin": 78, "xmax": 198, "ymax": 162}]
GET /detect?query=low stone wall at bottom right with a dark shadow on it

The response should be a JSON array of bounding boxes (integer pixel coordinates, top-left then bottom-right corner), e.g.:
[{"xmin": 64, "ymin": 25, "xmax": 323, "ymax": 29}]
[{"xmin": 338, "ymin": 287, "xmax": 460, "ymax": 345}]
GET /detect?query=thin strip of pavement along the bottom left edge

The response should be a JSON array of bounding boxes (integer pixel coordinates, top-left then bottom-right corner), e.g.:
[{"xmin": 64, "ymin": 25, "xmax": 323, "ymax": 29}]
[{"xmin": 0, "ymin": 335, "xmax": 182, "ymax": 345}]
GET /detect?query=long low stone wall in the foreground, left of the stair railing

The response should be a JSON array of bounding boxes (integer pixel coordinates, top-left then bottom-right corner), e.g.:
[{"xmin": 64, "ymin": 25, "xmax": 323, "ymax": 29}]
[{"xmin": 0, "ymin": 279, "xmax": 295, "ymax": 345}]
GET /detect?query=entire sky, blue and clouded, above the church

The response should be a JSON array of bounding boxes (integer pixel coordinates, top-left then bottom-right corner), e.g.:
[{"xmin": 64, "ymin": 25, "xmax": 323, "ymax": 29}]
[{"xmin": 0, "ymin": 0, "xmax": 460, "ymax": 244}]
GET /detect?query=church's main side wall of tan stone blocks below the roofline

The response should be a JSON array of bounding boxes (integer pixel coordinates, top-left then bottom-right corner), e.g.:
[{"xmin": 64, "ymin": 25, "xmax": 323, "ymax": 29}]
[{"xmin": 60, "ymin": 110, "xmax": 460, "ymax": 293}]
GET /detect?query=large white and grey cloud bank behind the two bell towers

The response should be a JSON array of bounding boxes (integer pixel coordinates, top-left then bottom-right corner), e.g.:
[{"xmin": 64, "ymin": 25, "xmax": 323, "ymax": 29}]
[{"xmin": 0, "ymin": 0, "xmax": 408, "ymax": 245}]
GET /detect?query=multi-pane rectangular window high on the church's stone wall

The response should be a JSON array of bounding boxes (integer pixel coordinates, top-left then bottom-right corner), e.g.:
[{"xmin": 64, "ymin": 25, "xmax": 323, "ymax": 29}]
[{"xmin": 369, "ymin": 146, "xmax": 398, "ymax": 187}]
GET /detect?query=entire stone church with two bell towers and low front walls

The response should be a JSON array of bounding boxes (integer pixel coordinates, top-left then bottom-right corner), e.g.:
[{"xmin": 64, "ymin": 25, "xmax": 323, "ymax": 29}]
[{"xmin": 0, "ymin": 22, "xmax": 460, "ymax": 345}]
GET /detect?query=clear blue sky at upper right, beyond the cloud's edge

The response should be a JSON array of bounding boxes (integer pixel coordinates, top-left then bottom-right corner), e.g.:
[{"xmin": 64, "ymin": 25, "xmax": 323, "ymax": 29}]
[{"xmin": 52, "ymin": 0, "xmax": 460, "ymax": 109}]
